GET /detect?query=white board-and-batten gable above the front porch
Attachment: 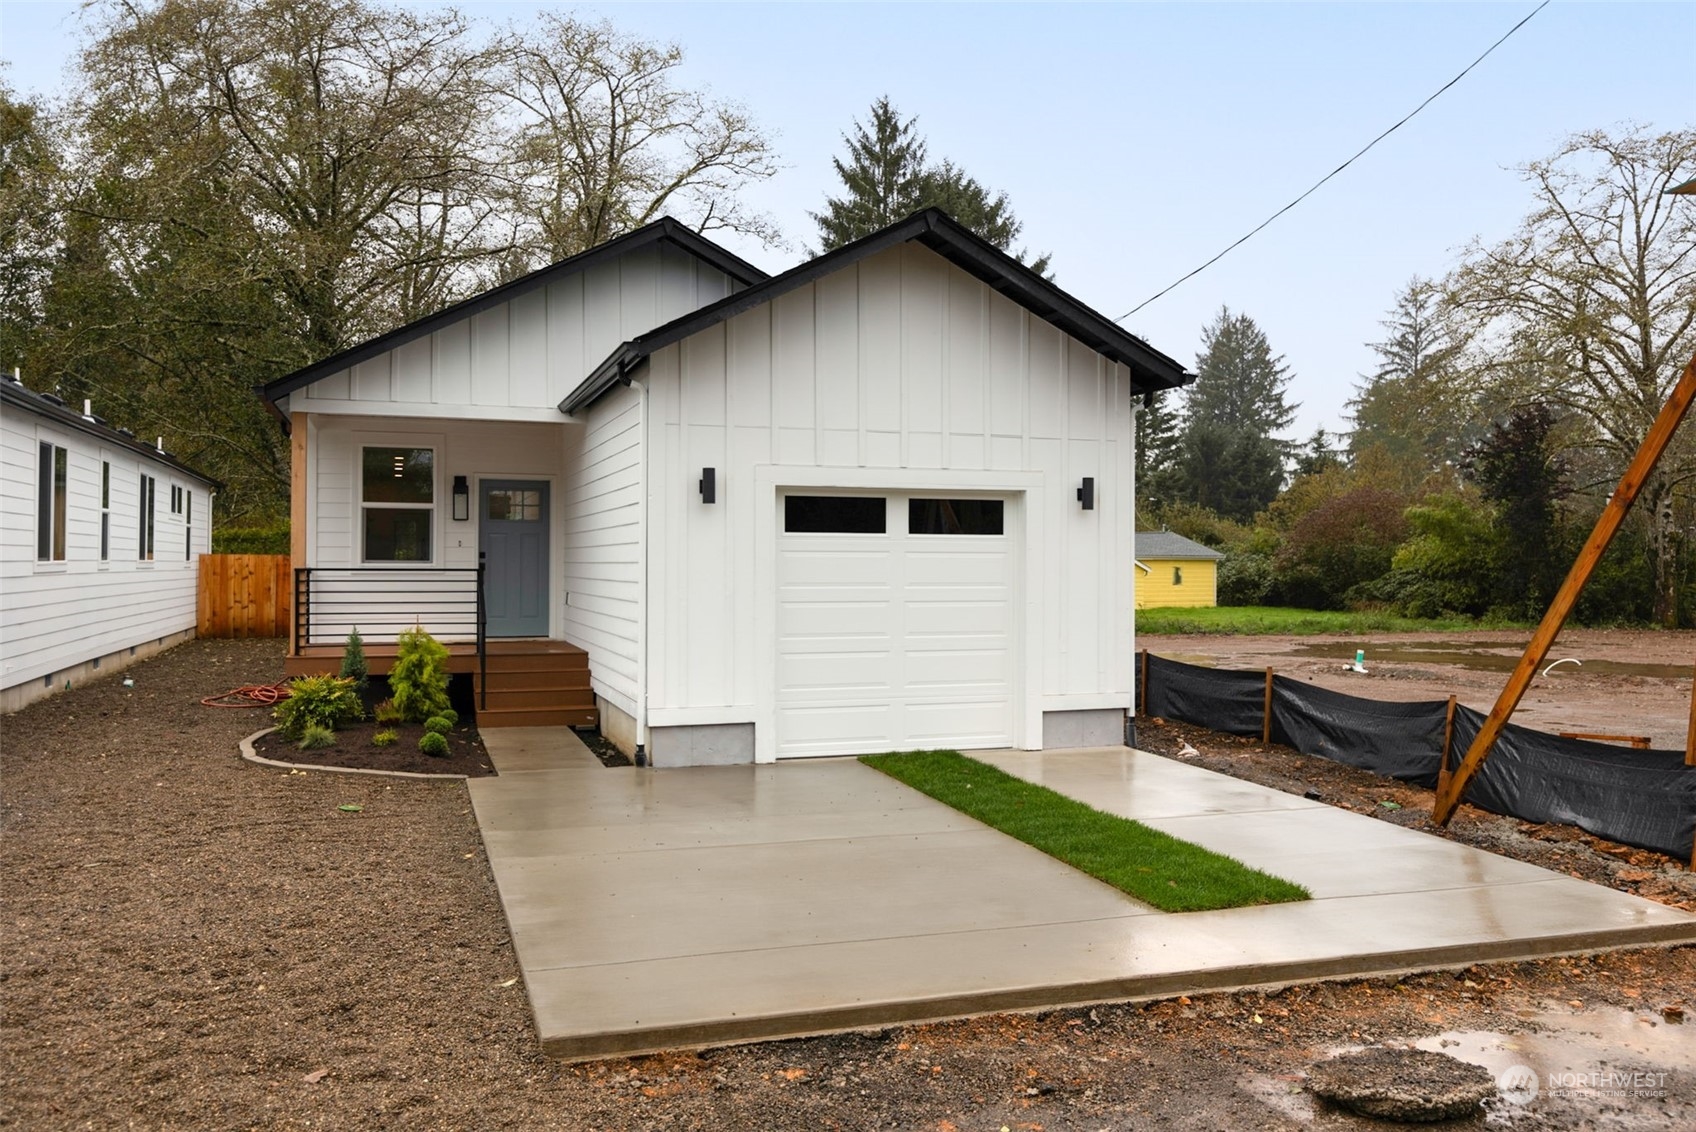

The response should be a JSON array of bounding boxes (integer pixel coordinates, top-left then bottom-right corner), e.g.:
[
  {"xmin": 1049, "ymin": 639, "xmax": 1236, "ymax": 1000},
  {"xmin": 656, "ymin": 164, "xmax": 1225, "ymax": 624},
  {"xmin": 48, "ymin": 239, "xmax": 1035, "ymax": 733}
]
[{"xmin": 288, "ymin": 243, "xmax": 738, "ymax": 423}]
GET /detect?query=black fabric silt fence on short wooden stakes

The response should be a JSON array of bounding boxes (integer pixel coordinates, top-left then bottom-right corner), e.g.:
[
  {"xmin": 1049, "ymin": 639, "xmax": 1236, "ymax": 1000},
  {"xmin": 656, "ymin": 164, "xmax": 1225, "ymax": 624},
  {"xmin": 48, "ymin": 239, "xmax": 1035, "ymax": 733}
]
[{"xmin": 1138, "ymin": 653, "xmax": 1696, "ymax": 859}]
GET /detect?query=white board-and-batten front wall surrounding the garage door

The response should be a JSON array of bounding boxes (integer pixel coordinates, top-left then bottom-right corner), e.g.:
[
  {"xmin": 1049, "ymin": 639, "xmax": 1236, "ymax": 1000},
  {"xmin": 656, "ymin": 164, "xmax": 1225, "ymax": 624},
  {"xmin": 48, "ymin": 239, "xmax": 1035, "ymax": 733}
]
[{"xmin": 646, "ymin": 244, "xmax": 1133, "ymax": 757}]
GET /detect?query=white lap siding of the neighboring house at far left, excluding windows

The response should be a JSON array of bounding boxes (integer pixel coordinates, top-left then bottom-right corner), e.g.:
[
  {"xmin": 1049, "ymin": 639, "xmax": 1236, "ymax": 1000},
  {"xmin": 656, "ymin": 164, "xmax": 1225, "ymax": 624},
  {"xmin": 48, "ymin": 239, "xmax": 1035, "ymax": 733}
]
[{"xmin": 0, "ymin": 407, "xmax": 212, "ymax": 687}]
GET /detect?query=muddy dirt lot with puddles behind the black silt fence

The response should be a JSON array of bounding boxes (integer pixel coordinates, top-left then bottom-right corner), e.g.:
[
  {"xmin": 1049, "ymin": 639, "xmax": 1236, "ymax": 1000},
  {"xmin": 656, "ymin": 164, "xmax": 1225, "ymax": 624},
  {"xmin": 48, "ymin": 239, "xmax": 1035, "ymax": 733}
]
[{"xmin": 1136, "ymin": 630, "xmax": 1696, "ymax": 750}]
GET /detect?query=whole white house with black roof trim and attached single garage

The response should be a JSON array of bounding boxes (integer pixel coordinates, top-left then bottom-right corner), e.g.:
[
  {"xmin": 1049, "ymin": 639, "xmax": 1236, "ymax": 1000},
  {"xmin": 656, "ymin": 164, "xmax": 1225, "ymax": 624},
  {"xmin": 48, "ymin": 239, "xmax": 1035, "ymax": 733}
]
[{"xmin": 265, "ymin": 210, "xmax": 1187, "ymax": 765}]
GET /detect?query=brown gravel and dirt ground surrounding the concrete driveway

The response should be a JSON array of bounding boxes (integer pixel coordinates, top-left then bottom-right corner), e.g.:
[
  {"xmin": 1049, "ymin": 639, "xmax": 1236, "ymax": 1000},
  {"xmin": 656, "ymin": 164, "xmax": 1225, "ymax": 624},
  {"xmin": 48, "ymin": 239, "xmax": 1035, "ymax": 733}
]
[{"xmin": 0, "ymin": 642, "xmax": 1696, "ymax": 1132}]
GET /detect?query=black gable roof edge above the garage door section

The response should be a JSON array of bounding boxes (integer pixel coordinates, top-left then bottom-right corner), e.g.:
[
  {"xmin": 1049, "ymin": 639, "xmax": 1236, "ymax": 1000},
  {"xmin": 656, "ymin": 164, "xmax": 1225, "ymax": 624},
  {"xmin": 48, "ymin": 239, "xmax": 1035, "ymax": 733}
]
[{"xmin": 560, "ymin": 209, "xmax": 1194, "ymax": 412}]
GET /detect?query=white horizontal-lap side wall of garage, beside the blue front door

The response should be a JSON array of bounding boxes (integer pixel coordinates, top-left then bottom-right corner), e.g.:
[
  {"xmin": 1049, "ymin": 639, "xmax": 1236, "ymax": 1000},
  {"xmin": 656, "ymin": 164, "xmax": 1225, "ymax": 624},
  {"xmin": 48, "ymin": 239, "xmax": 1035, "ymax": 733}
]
[{"xmin": 561, "ymin": 385, "xmax": 641, "ymax": 720}]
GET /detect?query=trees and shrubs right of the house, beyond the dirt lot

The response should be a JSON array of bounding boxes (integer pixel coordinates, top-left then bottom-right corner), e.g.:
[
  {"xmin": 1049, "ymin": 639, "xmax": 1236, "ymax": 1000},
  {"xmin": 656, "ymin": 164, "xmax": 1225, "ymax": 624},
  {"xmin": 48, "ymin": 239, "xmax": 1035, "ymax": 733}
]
[{"xmin": 1136, "ymin": 127, "xmax": 1696, "ymax": 638}]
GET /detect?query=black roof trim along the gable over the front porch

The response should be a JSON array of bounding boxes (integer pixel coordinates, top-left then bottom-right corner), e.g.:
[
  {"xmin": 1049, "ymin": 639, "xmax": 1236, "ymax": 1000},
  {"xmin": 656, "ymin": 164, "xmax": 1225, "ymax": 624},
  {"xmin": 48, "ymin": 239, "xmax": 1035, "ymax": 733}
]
[{"xmin": 258, "ymin": 216, "xmax": 770, "ymax": 407}]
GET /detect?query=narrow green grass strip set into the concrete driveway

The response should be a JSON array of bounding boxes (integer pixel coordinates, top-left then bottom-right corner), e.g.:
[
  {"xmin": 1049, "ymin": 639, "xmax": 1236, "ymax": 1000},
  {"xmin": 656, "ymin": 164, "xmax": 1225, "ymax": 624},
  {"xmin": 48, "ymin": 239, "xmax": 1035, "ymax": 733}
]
[{"xmin": 860, "ymin": 750, "xmax": 1311, "ymax": 911}]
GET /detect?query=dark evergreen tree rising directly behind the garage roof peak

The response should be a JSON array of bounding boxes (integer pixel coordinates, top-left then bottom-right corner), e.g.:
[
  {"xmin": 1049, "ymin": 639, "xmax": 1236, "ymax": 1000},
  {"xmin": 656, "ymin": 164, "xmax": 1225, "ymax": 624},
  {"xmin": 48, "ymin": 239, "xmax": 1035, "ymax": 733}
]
[{"xmin": 811, "ymin": 95, "xmax": 1050, "ymax": 275}]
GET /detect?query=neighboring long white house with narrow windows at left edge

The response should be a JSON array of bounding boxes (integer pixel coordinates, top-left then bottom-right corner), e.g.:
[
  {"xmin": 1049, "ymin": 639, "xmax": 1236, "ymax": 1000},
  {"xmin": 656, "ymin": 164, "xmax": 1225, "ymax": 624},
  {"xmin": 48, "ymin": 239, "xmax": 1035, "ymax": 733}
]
[{"xmin": 0, "ymin": 378, "xmax": 219, "ymax": 711}]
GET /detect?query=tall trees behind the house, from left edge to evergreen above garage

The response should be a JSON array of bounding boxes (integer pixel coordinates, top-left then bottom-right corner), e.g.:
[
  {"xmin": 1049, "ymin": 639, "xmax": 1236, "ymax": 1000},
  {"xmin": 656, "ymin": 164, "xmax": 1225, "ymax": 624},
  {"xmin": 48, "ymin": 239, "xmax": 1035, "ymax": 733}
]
[{"xmin": 0, "ymin": 0, "xmax": 1044, "ymax": 528}]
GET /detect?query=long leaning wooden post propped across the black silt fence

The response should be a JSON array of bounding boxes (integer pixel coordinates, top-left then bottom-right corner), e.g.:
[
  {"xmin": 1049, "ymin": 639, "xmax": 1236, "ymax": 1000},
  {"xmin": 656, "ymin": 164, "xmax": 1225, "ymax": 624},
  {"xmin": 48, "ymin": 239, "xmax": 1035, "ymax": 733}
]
[{"xmin": 1431, "ymin": 355, "xmax": 1696, "ymax": 825}]
